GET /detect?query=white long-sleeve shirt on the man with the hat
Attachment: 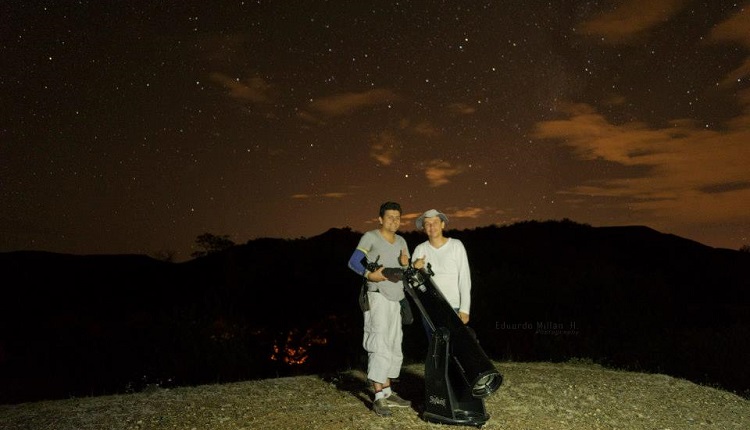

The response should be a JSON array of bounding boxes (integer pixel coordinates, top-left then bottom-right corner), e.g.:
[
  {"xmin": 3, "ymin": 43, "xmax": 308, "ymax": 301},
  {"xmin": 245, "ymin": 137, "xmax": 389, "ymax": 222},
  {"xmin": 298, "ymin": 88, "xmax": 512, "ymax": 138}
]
[{"xmin": 412, "ymin": 238, "xmax": 471, "ymax": 314}]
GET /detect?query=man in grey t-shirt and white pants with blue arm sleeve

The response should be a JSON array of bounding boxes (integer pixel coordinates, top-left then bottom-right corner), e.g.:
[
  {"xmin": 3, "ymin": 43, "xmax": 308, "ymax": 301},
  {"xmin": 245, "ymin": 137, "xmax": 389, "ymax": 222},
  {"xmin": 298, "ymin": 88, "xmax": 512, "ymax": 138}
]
[{"xmin": 349, "ymin": 202, "xmax": 411, "ymax": 416}]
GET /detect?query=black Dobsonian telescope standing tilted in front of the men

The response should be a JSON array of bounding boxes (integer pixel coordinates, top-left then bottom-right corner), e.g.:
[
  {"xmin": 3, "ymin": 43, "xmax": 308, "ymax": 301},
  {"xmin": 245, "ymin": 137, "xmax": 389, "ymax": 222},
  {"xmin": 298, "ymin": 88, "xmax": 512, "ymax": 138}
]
[{"xmin": 366, "ymin": 256, "xmax": 503, "ymax": 427}]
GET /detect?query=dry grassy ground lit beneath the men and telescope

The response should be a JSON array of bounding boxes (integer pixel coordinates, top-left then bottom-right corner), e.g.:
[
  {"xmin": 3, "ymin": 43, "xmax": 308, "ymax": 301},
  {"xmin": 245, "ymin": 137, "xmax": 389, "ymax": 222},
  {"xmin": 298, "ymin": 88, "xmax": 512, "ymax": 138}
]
[{"xmin": 0, "ymin": 362, "xmax": 750, "ymax": 430}]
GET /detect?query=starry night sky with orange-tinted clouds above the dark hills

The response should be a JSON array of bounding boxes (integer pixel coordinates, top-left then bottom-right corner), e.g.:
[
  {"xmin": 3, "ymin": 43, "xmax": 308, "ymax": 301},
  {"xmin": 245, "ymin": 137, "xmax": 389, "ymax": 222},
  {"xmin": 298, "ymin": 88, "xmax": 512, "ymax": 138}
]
[{"xmin": 0, "ymin": 0, "xmax": 750, "ymax": 261}]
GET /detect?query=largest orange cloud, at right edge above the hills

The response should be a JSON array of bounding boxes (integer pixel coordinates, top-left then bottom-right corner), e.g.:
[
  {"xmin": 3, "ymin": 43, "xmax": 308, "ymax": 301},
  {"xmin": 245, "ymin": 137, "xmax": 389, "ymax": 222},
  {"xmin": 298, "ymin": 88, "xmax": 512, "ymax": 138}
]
[{"xmin": 534, "ymin": 104, "xmax": 750, "ymax": 223}]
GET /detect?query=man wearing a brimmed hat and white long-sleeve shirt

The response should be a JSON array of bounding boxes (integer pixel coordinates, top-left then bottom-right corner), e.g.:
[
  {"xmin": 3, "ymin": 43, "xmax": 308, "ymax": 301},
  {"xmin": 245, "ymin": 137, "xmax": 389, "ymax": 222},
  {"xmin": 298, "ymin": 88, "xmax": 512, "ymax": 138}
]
[{"xmin": 412, "ymin": 209, "xmax": 471, "ymax": 324}]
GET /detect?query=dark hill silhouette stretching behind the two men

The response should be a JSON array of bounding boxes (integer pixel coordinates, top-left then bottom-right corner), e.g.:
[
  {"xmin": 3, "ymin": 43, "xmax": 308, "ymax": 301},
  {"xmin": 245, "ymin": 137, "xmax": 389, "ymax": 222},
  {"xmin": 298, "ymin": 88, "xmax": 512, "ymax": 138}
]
[{"xmin": 0, "ymin": 220, "xmax": 750, "ymax": 403}]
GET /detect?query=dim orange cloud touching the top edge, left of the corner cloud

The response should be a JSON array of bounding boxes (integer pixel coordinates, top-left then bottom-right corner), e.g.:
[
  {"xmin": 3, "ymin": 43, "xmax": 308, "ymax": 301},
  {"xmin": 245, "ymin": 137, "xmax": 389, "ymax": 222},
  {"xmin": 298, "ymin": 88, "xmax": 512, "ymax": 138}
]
[{"xmin": 581, "ymin": 0, "xmax": 685, "ymax": 43}]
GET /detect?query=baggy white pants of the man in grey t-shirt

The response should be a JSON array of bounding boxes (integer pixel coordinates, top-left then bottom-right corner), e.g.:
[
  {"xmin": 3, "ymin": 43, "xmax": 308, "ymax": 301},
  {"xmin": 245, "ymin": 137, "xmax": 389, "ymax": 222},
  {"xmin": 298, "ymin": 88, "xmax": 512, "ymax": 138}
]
[{"xmin": 362, "ymin": 292, "xmax": 404, "ymax": 384}]
